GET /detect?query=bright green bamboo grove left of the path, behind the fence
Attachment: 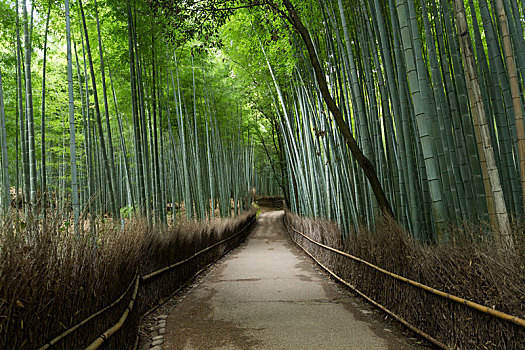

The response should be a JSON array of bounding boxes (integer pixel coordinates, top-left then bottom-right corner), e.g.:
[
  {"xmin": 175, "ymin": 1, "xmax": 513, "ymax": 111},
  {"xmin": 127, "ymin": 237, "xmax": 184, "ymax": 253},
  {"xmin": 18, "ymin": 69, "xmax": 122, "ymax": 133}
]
[{"xmin": 0, "ymin": 0, "xmax": 256, "ymax": 230}]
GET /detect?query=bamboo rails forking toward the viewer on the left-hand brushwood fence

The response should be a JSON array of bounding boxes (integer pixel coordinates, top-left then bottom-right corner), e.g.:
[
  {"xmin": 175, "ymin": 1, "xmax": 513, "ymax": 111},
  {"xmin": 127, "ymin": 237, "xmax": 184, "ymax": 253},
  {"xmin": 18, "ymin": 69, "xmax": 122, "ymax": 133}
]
[{"xmin": 38, "ymin": 215, "xmax": 257, "ymax": 350}]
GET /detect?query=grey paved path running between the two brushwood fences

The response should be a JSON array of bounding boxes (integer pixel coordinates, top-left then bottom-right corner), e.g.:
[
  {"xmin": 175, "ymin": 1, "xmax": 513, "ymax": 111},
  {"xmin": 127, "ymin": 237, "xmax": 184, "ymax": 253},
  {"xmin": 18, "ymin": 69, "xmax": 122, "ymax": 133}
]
[{"xmin": 161, "ymin": 212, "xmax": 422, "ymax": 350}]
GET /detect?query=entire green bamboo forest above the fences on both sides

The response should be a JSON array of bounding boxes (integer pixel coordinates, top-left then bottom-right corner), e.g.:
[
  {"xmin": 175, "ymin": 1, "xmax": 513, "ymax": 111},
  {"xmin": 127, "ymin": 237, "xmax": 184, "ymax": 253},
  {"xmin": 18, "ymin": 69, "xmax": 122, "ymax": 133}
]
[{"xmin": 0, "ymin": 0, "xmax": 525, "ymax": 249}]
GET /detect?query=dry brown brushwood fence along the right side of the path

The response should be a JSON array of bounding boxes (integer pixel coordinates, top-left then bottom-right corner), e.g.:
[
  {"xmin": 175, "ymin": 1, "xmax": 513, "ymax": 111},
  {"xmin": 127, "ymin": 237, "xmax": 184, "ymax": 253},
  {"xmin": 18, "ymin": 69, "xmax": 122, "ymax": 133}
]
[{"xmin": 285, "ymin": 212, "xmax": 525, "ymax": 349}]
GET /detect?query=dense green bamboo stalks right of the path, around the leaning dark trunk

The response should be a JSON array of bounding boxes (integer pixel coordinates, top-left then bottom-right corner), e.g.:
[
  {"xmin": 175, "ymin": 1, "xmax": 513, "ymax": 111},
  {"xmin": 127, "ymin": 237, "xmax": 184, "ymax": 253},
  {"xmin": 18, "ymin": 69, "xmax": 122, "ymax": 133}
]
[{"xmin": 244, "ymin": 0, "xmax": 525, "ymax": 248}]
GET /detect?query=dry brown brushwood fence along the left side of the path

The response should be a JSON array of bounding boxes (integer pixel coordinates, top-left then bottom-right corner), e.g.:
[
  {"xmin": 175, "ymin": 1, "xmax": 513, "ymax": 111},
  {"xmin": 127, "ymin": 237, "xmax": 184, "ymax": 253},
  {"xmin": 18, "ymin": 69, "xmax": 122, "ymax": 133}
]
[{"xmin": 0, "ymin": 212, "xmax": 254, "ymax": 349}]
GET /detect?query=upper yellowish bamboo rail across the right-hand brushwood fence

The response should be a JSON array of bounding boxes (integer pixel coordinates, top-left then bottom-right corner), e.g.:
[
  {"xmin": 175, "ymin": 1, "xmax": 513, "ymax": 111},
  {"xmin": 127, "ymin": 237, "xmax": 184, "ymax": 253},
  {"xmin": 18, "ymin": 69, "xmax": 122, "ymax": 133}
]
[{"xmin": 285, "ymin": 216, "xmax": 525, "ymax": 328}]
